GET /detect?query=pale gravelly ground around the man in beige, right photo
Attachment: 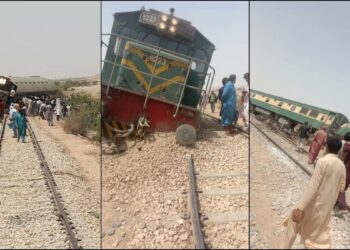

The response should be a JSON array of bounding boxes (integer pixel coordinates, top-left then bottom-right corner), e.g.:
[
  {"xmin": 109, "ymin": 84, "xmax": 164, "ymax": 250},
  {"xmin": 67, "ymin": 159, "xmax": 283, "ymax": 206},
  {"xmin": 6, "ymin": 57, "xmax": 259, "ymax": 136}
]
[{"xmin": 250, "ymin": 127, "xmax": 350, "ymax": 249}]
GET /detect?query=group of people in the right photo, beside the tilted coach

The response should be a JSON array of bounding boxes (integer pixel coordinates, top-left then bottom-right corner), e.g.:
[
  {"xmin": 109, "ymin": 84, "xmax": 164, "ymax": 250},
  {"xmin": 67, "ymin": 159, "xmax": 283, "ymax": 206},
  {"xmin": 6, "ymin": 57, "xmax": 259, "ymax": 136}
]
[{"xmin": 280, "ymin": 131, "xmax": 350, "ymax": 249}]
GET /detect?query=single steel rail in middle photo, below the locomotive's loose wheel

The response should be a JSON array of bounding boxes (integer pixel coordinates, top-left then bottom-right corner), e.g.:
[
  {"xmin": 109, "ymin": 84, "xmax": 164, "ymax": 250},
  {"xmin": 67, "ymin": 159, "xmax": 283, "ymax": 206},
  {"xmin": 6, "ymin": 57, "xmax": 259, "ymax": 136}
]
[{"xmin": 188, "ymin": 155, "xmax": 205, "ymax": 249}]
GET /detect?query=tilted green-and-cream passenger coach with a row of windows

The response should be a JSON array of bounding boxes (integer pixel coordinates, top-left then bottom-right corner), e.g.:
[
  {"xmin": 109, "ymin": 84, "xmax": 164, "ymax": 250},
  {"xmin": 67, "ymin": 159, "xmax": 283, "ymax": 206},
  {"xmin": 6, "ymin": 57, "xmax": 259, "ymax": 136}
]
[{"xmin": 250, "ymin": 89, "xmax": 349, "ymax": 135}]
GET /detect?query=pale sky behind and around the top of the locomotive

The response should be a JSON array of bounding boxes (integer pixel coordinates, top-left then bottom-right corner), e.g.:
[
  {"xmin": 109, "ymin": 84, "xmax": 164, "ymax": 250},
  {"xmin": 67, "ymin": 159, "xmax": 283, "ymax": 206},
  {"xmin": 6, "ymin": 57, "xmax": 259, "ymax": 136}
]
[{"xmin": 102, "ymin": 1, "xmax": 248, "ymax": 87}]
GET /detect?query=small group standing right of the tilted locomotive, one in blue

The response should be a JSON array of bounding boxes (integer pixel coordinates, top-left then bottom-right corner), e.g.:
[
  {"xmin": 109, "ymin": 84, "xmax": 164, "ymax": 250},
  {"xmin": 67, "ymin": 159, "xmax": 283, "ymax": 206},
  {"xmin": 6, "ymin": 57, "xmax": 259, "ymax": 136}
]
[{"xmin": 208, "ymin": 73, "xmax": 249, "ymax": 133}]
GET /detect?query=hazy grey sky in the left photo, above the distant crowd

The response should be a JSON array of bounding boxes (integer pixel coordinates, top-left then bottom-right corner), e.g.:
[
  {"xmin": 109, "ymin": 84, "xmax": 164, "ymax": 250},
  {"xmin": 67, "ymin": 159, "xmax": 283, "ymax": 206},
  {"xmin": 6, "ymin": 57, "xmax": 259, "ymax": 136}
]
[{"xmin": 0, "ymin": 2, "xmax": 101, "ymax": 78}]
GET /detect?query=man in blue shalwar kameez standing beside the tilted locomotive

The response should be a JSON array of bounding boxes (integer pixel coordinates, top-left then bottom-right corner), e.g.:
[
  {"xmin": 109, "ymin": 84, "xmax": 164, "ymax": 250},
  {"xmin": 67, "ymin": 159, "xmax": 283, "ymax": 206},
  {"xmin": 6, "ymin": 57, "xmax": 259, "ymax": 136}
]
[{"xmin": 221, "ymin": 75, "xmax": 236, "ymax": 132}]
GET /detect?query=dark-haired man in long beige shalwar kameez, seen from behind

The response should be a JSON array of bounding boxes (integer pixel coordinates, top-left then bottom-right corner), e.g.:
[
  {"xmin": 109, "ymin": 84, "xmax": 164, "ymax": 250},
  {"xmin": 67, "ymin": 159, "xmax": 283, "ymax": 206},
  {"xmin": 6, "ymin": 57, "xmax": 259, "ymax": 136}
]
[{"xmin": 280, "ymin": 136, "xmax": 345, "ymax": 249}]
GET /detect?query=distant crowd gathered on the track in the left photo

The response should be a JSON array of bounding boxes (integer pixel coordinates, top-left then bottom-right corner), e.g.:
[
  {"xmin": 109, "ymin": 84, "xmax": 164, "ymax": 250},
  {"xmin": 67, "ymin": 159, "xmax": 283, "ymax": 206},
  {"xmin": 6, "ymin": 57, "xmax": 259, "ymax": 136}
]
[{"xmin": 6, "ymin": 90, "xmax": 71, "ymax": 143}]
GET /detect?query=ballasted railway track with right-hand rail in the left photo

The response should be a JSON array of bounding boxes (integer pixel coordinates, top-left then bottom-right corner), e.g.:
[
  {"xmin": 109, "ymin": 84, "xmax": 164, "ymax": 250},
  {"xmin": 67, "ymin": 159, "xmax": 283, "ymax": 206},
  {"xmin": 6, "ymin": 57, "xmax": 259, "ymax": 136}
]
[{"xmin": 0, "ymin": 122, "xmax": 79, "ymax": 249}]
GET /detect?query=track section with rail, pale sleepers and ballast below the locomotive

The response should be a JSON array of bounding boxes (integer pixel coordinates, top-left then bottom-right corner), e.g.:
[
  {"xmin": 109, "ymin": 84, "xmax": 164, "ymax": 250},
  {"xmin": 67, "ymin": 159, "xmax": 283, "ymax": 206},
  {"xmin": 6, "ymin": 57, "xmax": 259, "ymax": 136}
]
[{"xmin": 188, "ymin": 156, "xmax": 248, "ymax": 249}]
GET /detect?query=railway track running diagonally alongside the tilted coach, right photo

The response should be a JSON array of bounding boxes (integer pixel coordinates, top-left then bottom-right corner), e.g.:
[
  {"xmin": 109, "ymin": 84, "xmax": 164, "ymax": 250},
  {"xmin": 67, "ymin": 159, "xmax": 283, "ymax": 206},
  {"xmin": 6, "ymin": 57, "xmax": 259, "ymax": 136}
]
[{"xmin": 250, "ymin": 120, "xmax": 312, "ymax": 176}]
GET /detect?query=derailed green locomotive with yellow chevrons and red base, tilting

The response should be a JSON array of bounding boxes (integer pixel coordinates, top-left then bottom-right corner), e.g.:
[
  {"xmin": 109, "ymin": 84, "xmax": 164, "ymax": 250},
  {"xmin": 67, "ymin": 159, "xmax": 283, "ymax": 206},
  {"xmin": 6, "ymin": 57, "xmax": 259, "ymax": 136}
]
[{"xmin": 102, "ymin": 9, "xmax": 215, "ymax": 144}]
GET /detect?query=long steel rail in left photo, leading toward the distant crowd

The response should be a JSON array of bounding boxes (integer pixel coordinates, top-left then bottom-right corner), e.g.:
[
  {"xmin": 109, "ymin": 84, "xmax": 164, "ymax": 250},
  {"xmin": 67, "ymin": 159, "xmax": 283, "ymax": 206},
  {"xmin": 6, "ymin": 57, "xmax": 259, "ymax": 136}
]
[{"xmin": 27, "ymin": 120, "xmax": 79, "ymax": 249}]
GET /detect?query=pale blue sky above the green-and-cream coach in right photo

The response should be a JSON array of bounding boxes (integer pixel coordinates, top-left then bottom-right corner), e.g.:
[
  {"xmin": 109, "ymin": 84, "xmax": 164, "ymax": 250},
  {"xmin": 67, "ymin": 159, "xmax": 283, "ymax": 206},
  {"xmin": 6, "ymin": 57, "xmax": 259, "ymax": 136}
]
[{"xmin": 250, "ymin": 2, "xmax": 350, "ymax": 119}]
